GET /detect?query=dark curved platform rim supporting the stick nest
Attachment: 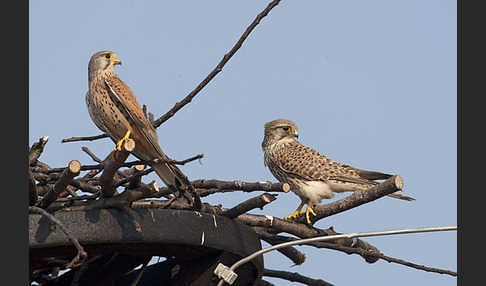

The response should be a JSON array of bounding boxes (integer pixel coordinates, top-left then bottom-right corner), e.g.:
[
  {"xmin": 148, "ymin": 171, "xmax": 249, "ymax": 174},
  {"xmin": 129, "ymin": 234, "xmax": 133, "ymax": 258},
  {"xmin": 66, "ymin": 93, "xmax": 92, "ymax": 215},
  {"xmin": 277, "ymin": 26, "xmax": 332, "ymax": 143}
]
[{"xmin": 29, "ymin": 209, "xmax": 263, "ymax": 285}]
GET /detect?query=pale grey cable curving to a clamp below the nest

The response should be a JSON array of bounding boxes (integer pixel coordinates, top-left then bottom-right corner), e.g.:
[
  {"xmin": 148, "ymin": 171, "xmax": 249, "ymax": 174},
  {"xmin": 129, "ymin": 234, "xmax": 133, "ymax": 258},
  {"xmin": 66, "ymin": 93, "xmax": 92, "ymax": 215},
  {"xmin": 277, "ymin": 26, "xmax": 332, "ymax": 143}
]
[{"xmin": 215, "ymin": 226, "xmax": 457, "ymax": 286}]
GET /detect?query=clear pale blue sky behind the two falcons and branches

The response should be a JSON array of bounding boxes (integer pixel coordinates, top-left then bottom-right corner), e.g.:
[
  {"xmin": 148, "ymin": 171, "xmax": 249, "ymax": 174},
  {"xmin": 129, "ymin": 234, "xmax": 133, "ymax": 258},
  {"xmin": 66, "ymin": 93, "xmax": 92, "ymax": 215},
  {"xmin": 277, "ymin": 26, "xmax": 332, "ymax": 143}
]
[{"xmin": 29, "ymin": 0, "xmax": 457, "ymax": 286}]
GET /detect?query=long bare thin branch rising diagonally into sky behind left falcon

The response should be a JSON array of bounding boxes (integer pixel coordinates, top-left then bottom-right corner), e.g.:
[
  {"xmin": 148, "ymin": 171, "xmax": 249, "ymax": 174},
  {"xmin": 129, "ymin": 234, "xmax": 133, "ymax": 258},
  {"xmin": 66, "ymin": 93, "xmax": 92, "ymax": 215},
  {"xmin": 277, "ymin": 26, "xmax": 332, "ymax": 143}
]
[{"xmin": 153, "ymin": 0, "xmax": 280, "ymax": 128}]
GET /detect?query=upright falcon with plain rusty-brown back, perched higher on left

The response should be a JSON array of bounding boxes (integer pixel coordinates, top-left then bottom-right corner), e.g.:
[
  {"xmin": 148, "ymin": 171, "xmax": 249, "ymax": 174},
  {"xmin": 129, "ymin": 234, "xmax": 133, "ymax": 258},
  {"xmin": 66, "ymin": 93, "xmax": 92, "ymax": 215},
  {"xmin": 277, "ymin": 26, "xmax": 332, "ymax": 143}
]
[{"xmin": 86, "ymin": 51, "xmax": 190, "ymax": 196}]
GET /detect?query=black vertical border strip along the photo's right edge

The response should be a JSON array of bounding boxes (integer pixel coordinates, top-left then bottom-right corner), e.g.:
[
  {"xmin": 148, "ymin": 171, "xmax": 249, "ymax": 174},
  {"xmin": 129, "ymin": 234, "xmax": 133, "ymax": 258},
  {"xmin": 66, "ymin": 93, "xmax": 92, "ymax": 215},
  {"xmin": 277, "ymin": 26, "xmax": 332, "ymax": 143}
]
[{"xmin": 458, "ymin": 1, "xmax": 486, "ymax": 285}]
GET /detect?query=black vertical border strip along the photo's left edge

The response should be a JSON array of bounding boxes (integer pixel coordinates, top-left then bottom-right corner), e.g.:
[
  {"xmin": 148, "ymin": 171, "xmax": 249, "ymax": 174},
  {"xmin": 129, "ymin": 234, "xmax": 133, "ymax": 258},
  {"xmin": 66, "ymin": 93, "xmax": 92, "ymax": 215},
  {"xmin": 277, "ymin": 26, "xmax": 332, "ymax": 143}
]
[{"xmin": 0, "ymin": 0, "xmax": 29, "ymax": 285}]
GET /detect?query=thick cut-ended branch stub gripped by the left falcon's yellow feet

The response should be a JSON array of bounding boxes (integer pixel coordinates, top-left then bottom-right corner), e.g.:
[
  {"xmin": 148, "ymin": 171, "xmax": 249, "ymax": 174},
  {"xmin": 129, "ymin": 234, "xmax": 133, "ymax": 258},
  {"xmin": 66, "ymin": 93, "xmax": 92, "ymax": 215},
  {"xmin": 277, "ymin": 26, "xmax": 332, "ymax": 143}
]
[{"xmin": 100, "ymin": 138, "xmax": 135, "ymax": 198}]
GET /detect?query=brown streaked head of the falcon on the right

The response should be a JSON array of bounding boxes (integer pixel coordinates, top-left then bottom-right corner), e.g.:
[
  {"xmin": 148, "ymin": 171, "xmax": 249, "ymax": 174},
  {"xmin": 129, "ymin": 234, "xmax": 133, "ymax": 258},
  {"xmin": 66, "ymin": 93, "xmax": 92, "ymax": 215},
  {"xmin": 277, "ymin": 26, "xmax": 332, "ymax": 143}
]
[{"xmin": 262, "ymin": 119, "xmax": 299, "ymax": 145}]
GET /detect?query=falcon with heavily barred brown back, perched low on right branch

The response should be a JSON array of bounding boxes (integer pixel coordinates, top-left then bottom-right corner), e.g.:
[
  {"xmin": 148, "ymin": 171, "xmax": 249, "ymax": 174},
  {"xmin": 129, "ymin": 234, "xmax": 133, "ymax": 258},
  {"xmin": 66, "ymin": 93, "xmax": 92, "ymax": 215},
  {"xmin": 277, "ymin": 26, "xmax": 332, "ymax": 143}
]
[{"xmin": 262, "ymin": 119, "xmax": 414, "ymax": 224}]
